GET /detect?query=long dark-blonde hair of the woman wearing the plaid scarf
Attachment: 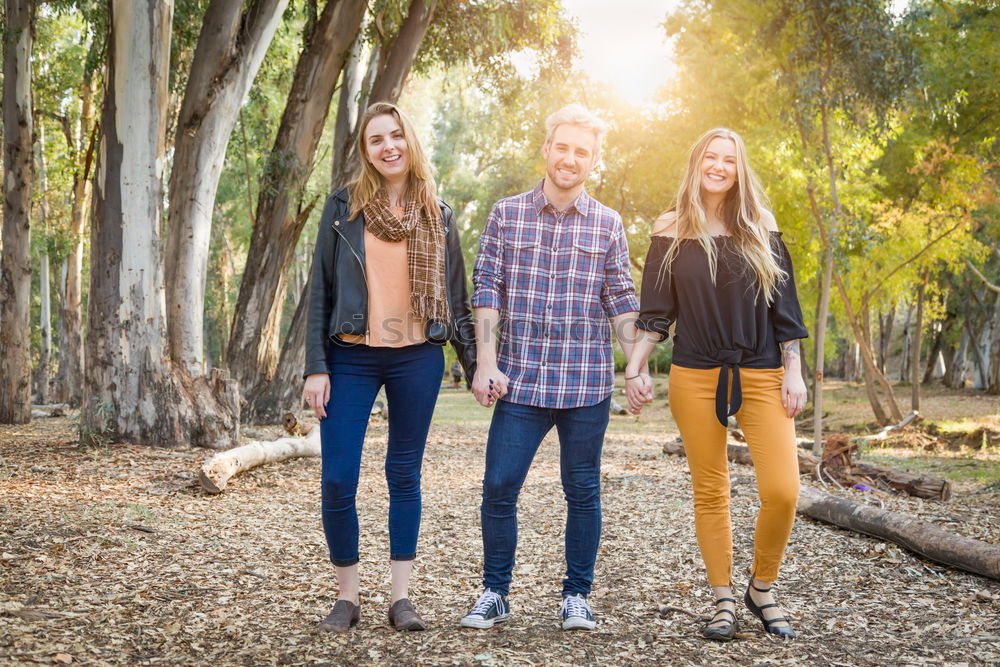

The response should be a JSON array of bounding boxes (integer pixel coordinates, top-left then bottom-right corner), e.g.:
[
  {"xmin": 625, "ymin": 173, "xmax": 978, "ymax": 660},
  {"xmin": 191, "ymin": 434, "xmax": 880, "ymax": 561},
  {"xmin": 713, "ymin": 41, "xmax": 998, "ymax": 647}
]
[{"xmin": 347, "ymin": 102, "xmax": 441, "ymax": 220}]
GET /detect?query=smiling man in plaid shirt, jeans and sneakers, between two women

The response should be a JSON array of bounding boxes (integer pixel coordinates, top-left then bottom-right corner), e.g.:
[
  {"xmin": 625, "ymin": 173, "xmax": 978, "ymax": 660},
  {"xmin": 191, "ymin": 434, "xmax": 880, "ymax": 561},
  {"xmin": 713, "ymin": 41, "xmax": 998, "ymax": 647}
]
[{"xmin": 461, "ymin": 104, "xmax": 651, "ymax": 630}]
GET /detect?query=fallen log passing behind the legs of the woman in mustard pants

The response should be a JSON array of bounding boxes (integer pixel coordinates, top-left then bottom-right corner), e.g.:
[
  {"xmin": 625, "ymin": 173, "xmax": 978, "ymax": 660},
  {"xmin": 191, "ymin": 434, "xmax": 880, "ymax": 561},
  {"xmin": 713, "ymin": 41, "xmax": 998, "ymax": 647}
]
[{"xmin": 663, "ymin": 438, "xmax": 951, "ymax": 500}]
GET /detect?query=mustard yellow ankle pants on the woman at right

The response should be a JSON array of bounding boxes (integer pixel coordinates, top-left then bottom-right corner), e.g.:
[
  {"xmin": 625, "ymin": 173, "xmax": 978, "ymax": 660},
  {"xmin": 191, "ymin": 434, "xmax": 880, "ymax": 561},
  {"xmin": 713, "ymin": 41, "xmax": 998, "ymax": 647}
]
[{"xmin": 670, "ymin": 366, "xmax": 799, "ymax": 586}]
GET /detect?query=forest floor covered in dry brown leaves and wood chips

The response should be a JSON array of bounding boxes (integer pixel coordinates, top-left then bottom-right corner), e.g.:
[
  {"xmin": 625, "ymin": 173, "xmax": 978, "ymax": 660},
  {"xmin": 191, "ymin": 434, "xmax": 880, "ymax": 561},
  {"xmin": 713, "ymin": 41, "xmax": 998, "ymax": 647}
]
[{"xmin": 0, "ymin": 382, "xmax": 1000, "ymax": 667}]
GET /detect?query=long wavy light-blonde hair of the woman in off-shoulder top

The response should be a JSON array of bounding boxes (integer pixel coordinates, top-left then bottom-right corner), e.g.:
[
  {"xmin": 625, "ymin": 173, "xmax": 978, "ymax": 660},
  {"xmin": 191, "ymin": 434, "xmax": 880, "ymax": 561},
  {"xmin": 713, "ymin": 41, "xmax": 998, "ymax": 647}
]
[{"xmin": 659, "ymin": 127, "xmax": 788, "ymax": 305}]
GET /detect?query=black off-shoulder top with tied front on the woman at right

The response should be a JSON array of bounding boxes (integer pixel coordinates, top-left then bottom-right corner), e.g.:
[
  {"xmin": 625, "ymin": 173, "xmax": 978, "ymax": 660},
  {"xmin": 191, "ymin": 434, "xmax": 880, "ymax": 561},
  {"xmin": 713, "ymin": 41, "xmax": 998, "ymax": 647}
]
[{"xmin": 635, "ymin": 232, "xmax": 809, "ymax": 425}]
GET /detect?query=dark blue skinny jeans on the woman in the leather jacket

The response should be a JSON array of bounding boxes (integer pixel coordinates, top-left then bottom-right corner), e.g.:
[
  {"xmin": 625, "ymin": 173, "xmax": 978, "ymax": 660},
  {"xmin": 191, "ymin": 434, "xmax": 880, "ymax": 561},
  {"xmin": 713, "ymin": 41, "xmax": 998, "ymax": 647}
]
[{"xmin": 320, "ymin": 343, "xmax": 444, "ymax": 567}]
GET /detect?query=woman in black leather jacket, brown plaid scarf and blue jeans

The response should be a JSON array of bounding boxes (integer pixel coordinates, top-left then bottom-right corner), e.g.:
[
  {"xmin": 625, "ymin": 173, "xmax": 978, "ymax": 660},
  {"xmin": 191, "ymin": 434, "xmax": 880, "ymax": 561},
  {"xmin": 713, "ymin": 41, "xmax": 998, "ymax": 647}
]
[{"xmin": 305, "ymin": 102, "xmax": 476, "ymax": 632}]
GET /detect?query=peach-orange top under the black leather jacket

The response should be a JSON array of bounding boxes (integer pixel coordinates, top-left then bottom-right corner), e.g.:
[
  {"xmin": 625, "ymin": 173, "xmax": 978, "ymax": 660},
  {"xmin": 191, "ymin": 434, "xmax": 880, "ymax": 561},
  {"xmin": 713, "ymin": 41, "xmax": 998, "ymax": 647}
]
[{"xmin": 341, "ymin": 206, "xmax": 427, "ymax": 347}]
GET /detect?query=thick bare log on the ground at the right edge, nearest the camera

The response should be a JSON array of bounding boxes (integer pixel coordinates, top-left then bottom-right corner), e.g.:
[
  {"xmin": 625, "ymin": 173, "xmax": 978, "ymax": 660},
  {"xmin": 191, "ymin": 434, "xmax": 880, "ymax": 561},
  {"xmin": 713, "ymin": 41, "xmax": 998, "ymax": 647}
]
[{"xmin": 798, "ymin": 486, "xmax": 1000, "ymax": 580}]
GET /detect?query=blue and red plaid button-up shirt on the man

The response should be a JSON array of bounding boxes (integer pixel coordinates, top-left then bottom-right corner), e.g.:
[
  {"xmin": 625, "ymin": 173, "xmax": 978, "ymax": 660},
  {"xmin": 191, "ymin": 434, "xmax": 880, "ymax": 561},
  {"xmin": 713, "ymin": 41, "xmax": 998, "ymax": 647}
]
[{"xmin": 472, "ymin": 183, "xmax": 639, "ymax": 409}]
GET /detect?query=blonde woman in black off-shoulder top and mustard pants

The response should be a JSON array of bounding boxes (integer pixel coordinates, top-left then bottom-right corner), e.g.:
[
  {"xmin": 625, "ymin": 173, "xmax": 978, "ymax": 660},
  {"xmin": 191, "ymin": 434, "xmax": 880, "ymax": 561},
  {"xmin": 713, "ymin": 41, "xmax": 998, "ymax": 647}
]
[{"xmin": 625, "ymin": 129, "xmax": 808, "ymax": 641}]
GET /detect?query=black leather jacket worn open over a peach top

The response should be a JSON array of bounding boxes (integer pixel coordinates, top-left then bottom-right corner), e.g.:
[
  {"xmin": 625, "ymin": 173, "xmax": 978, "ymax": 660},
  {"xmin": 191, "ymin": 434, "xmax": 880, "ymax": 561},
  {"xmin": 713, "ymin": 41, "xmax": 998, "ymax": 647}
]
[{"xmin": 304, "ymin": 188, "xmax": 476, "ymax": 380}]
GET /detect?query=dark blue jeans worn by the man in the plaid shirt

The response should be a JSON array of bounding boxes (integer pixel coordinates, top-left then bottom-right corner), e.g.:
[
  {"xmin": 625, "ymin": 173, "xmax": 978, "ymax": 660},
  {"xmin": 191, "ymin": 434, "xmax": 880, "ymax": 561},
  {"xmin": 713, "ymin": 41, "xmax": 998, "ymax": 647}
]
[{"xmin": 481, "ymin": 397, "xmax": 611, "ymax": 595}]
